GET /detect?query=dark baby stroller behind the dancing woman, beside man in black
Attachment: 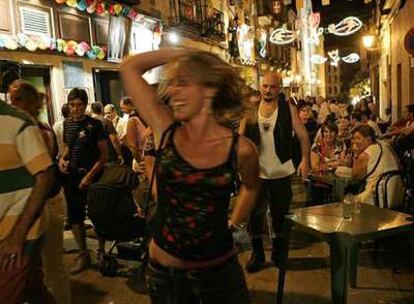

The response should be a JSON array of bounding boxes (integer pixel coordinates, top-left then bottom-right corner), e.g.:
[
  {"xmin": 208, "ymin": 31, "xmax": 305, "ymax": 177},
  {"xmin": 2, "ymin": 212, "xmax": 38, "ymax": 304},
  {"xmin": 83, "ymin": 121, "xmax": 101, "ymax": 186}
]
[{"xmin": 88, "ymin": 164, "xmax": 148, "ymax": 277}]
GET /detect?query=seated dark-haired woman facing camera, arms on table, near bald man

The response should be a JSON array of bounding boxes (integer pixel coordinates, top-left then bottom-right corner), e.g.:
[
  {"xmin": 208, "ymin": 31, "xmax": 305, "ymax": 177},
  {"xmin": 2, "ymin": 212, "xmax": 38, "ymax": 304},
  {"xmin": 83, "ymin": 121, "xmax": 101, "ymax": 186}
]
[{"xmin": 311, "ymin": 122, "xmax": 346, "ymax": 172}]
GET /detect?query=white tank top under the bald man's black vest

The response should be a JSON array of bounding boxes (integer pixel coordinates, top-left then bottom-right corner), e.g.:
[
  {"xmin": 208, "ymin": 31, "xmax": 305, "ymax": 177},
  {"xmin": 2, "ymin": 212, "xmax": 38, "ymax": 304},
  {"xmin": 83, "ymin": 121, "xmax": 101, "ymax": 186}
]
[{"xmin": 258, "ymin": 109, "xmax": 295, "ymax": 179}]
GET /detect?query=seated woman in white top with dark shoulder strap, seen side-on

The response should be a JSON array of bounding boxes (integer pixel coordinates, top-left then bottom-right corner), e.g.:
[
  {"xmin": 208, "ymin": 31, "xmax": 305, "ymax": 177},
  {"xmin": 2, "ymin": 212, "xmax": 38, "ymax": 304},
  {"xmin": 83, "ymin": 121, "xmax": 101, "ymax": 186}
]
[{"xmin": 352, "ymin": 124, "xmax": 404, "ymax": 209}]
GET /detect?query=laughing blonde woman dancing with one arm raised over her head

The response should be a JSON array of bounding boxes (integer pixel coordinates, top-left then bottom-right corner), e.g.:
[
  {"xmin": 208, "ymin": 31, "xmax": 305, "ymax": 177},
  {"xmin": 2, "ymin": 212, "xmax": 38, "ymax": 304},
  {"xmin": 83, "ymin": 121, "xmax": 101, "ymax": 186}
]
[{"xmin": 122, "ymin": 49, "xmax": 258, "ymax": 304}]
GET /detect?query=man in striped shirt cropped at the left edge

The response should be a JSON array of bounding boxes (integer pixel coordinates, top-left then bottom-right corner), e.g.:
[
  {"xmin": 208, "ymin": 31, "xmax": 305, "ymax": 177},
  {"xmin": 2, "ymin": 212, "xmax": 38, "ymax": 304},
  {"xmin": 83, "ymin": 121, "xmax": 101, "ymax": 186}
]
[{"xmin": 0, "ymin": 101, "xmax": 54, "ymax": 304}]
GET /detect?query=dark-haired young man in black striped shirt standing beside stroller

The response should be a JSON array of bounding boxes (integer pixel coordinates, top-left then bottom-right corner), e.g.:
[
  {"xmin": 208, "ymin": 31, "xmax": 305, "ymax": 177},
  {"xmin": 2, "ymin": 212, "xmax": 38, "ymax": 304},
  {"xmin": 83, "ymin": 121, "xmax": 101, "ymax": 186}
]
[{"xmin": 59, "ymin": 88, "xmax": 108, "ymax": 274}]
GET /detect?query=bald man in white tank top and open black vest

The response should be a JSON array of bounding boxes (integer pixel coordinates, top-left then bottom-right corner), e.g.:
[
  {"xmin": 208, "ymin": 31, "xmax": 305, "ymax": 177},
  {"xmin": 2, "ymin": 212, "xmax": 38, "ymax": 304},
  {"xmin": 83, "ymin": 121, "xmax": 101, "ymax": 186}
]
[{"xmin": 245, "ymin": 72, "xmax": 310, "ymax": 272}]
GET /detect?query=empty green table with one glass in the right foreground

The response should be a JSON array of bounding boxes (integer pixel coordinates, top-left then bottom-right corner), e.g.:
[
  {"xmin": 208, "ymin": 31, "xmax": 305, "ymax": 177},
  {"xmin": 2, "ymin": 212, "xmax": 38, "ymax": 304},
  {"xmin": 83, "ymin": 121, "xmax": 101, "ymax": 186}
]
[{"xmin": 277, "ymin": 203, "xmax": 414, "ymax": 304}]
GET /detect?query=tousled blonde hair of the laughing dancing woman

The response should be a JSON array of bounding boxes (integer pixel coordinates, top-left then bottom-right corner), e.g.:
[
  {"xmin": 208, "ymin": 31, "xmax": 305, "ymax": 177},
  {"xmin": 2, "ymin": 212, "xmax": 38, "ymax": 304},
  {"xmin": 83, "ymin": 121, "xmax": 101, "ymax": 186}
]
[{"xmin": 161, "ymin": 51, "xmax": 245, "ymax": 120}]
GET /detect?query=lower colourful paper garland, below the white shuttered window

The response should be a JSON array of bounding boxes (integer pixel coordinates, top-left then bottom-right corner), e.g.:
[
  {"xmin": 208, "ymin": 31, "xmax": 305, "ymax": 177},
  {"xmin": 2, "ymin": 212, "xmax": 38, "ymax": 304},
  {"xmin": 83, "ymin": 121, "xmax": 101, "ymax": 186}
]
[{"xmin": 0, "ymin": 33, "xmax": 107, "ymax": 60}]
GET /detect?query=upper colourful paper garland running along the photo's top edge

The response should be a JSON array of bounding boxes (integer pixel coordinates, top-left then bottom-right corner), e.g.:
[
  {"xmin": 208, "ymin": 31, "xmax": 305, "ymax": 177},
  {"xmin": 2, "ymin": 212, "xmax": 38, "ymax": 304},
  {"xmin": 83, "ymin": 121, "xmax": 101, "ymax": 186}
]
[{"xmin": 55, "ymin": 0, "xmax": 139, "ymax": 20}]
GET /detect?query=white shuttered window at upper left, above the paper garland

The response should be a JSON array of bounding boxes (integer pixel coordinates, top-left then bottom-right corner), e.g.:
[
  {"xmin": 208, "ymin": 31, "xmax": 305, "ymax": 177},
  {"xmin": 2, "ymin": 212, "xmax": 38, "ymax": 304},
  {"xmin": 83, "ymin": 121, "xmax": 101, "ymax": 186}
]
[{"xmin": 20, "ymin": 6, "xmax": 52, "ymax": 36}]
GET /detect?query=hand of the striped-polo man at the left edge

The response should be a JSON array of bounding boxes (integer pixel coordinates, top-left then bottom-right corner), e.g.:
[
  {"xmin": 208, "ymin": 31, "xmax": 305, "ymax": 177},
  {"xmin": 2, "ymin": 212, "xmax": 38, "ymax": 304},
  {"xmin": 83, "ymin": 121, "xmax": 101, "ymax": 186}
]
[{"xmin": 0, "ymin": 232, "xmax": 25, "ymax": 271}]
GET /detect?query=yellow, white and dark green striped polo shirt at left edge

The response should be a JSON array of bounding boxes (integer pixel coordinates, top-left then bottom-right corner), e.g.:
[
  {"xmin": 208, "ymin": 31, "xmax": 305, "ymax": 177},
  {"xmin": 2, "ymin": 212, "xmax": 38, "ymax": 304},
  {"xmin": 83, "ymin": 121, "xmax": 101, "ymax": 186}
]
[{"xmin": 0, "ymin": 101, "xmax": 52, "ymax": 240}]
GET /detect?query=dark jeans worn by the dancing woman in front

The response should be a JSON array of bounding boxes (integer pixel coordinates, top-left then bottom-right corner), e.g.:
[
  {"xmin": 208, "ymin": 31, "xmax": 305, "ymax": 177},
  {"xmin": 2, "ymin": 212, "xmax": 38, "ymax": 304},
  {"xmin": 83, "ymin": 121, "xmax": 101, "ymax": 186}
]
[{"xmin": 147, "ymin": 256, "xmax": 250, "ymax": 304}]
